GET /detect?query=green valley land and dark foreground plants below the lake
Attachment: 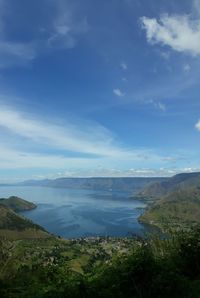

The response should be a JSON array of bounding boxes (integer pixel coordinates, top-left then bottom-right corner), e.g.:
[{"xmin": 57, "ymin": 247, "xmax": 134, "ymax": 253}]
[{"xmin": 0, "ymin": 228, "xmax": 200, "ymax": 298}]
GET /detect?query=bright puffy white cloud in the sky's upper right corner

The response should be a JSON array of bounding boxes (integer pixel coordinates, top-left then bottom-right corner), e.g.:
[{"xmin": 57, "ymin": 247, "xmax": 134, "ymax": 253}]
[{"xmin": 141, "ymin": 1, "xmax": 200, "ymax": 56}]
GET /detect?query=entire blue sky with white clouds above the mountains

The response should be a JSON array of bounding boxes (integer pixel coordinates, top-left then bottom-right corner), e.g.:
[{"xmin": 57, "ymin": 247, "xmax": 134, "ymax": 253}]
[{"xmin": 0, "ymin": 0, "xmax": 200, "ymax": 183}]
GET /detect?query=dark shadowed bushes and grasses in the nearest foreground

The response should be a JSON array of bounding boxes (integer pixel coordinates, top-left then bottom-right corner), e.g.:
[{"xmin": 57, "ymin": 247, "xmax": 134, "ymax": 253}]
[{"xmin": 0, "ymin": 228, "xmax": 200, "ymax": 298}]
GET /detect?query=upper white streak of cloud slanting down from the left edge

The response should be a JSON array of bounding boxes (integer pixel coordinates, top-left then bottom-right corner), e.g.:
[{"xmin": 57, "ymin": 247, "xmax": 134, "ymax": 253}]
[{"xmin": 0, "ymin": 107, "xmax": 117, "ymax": 155}]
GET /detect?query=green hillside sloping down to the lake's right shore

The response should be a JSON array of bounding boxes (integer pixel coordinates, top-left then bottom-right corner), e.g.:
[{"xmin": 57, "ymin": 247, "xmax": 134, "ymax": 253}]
[{"xmin": 138, "ymin": 172, "xmax": 200, "ymax": 229}]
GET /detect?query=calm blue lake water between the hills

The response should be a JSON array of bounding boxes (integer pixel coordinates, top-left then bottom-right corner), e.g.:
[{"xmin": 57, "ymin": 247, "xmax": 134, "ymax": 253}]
[{"xmin": 0, "ymin": 186, "xmax": 145, "ymax": 238}]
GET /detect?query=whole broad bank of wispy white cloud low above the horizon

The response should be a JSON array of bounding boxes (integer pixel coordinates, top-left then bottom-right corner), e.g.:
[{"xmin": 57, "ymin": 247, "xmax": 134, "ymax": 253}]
[{"xmin": 0, "ymin": 105, "xmax": 195, "ymax": 177}]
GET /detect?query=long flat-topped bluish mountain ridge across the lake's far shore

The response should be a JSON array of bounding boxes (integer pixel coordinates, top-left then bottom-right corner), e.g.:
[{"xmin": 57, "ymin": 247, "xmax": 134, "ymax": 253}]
[{"xmin": 18, "ymin": 177, "xmax": 166, "ymax": 193}]
